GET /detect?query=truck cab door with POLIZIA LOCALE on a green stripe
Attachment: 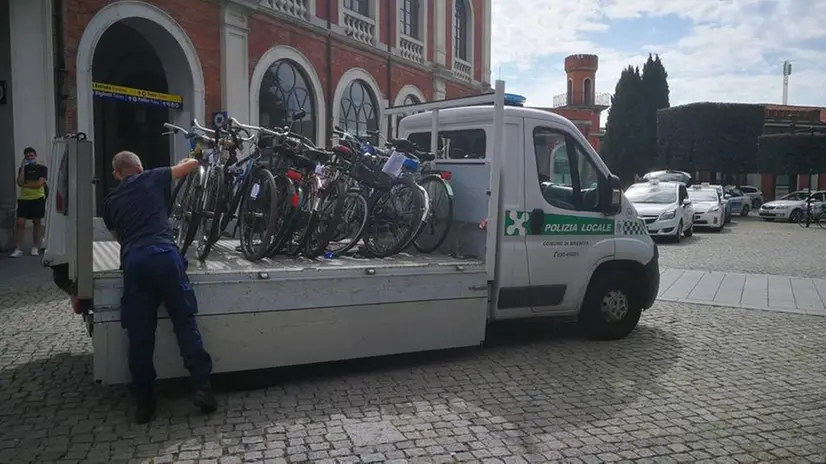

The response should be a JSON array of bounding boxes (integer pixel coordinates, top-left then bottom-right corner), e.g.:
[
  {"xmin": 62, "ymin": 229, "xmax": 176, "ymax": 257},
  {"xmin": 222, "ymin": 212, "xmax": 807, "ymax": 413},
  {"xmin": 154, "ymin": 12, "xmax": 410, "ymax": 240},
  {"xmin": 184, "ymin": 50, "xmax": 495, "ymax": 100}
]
[{"xmin": 524, "ymin": 119, "xmax": 614, "ymax": 312}]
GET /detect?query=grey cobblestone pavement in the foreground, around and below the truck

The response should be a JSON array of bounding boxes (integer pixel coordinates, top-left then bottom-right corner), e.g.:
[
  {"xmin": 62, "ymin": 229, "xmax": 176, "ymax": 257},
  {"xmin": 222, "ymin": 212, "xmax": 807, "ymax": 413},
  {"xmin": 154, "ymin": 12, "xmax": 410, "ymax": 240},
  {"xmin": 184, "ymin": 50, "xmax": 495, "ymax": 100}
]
[{"xmin": 0, "ymin": 270, "xmax": 826, "ymax": 463}]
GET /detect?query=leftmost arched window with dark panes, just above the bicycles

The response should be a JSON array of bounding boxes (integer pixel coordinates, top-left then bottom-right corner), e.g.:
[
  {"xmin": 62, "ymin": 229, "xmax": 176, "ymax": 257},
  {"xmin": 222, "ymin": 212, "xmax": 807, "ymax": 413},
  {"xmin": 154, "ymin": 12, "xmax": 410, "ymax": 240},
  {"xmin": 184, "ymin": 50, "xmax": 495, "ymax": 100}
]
[{"xmin": 258, "ymin": 60, "xmax": 316, "ymax": 140}]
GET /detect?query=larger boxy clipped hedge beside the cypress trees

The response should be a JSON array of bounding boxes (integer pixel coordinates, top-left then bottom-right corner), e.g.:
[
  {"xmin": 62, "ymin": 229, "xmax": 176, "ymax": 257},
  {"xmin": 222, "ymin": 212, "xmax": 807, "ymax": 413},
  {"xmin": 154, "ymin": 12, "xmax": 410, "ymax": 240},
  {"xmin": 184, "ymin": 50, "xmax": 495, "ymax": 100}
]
[{"xmin": 657, "ymin": 103, "xmax": 765, "ymax": 174}]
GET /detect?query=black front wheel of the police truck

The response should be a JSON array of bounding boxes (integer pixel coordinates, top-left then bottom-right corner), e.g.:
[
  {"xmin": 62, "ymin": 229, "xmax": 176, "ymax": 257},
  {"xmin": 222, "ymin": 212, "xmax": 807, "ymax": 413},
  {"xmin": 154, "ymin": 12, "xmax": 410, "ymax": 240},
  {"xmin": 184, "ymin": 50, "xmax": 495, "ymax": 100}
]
[{"xmin": 579, "ymin": 269, "xmax": 642, "ymax": 340}]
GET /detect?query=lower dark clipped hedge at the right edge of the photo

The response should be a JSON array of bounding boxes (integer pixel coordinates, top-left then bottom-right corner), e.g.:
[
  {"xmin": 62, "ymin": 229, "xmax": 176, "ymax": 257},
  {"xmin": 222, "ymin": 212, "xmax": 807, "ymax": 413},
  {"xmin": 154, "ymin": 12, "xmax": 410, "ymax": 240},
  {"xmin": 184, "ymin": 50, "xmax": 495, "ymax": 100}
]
[{"xmin": 757, "ymin": 134, "xmax": 826, "ymax": 174}]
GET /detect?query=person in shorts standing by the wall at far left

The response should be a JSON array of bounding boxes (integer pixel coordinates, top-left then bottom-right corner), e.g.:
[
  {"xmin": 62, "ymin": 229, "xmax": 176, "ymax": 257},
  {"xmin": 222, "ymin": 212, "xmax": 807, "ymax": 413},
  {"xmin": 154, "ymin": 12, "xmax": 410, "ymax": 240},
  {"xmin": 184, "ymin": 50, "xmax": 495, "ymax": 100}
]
[{"xmin": 11, "ymin": 147, "xmax": 48, "ymax": 258}]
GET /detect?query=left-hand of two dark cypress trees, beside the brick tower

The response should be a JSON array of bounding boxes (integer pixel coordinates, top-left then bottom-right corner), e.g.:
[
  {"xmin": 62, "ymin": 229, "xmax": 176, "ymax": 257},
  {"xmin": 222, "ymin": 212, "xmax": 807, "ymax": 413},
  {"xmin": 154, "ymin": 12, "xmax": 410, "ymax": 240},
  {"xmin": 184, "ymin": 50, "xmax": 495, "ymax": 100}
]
[{"xmin": 602, "ymin": 66, "xmax": 647, "ymax": 183}]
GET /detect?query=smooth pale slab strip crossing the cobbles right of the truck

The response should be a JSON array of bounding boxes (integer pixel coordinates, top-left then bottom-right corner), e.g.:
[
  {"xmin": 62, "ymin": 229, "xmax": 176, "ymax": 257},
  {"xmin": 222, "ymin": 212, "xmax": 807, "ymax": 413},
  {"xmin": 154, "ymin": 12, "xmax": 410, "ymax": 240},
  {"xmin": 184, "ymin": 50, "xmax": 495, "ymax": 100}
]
[{"xmin": 657, "ymin": 269, "xmax": 826, "ymax": 316}]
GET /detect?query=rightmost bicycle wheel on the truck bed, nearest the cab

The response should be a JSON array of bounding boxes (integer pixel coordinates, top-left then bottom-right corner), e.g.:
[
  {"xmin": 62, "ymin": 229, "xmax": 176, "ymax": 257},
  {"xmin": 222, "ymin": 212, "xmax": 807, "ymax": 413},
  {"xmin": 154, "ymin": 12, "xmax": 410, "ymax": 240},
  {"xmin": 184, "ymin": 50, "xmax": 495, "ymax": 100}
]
[{"xmin": 413, "ymin": 176, "xmax": 453, "ymax": 253}]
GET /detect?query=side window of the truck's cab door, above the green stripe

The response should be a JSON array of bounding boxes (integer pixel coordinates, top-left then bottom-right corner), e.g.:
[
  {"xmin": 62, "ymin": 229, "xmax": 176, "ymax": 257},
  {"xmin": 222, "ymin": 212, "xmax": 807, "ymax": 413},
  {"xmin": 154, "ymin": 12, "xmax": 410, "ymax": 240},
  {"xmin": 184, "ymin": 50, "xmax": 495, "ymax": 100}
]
[{"xmin": 533, "ymin": 127, "xmax": 599, "ymax": 211}]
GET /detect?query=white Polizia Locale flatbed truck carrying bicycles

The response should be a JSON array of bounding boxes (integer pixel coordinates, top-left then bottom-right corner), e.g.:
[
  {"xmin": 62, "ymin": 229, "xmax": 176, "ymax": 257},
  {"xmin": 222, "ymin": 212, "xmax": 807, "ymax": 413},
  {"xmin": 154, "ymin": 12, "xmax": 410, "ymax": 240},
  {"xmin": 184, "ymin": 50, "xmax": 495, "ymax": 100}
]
[{"xmin": 42, "ymin": 81, "xmax": 659, "ymax": 384}]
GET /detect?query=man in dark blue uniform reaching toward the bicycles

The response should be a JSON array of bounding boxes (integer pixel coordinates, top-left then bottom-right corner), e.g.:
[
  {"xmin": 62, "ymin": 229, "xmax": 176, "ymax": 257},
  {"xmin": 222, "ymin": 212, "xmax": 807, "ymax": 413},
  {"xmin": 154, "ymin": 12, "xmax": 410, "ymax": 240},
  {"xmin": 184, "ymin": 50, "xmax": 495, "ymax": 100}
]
[{"xmin": 103, "ymin": 151, "xmax": 217, "ymax": 423}]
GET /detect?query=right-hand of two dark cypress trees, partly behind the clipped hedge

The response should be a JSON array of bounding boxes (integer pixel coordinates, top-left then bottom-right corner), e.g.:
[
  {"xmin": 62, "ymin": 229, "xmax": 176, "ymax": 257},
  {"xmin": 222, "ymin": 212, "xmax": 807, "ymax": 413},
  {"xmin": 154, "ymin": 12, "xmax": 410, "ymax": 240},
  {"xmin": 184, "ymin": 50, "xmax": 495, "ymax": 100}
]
[{"xmin": 642, "ymin": 53, "xmax": 671, "ymax": 171}]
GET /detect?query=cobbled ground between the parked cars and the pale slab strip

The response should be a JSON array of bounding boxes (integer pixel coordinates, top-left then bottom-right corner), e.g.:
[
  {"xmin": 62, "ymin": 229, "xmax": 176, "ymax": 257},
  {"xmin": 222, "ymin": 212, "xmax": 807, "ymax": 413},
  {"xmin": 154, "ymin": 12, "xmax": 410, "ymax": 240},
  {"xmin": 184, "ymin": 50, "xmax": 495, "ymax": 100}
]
[{"xmin": 659, "ymin": 217, "xmax": 826, "ymax": 278}]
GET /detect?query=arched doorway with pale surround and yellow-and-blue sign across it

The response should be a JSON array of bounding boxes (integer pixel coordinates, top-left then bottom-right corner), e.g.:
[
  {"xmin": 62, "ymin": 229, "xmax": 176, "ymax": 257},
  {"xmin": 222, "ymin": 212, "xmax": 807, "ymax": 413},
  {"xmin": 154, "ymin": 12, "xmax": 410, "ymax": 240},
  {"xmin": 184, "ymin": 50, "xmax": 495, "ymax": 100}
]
[{"xmin": 77, "ymin": 0, "xmax": 205, "ymax": 213}]
